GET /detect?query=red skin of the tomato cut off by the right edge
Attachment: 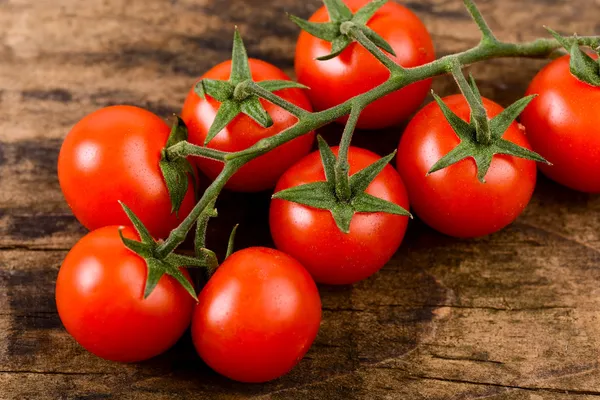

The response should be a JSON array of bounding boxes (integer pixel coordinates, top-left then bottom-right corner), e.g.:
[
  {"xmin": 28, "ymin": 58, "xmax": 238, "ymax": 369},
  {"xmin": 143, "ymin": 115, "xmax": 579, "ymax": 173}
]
[{"xmin": 521, "ymin": 56, "xmax": 600, "ymax": 193}]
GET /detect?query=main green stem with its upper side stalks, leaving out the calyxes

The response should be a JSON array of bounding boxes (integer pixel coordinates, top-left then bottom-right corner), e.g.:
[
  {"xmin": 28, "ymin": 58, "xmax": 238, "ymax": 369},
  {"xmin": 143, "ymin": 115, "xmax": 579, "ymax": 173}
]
[{"xmin": 156, "ymin": 0, "xmax": 600, "ymax": 257}]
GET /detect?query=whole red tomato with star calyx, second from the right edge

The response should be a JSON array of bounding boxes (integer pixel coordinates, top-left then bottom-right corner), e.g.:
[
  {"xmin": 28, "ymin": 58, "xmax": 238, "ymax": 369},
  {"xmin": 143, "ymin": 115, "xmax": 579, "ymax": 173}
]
[{"xmin": 397, "ymin": 68, "xmax": 545, "ymax": 238}]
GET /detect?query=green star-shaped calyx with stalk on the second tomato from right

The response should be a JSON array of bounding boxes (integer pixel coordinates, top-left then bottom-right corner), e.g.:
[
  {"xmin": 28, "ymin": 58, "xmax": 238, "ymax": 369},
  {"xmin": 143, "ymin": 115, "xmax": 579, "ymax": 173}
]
[{"xmin": 427, "ymin": 64, "xmax": 549, "ymax": 183}]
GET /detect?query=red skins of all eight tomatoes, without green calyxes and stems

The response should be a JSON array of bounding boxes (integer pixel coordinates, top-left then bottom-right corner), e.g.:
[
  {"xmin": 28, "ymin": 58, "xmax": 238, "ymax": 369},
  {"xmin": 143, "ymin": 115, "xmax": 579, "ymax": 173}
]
[{"xmin": 56, "ymin": 0, "xmax": 600, "ymax": 382}]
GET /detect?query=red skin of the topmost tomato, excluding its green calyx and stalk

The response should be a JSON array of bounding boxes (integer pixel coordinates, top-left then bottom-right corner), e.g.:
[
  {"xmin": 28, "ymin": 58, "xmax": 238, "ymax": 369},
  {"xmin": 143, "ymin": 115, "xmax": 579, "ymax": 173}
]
[{"xmin": 295, "ymin": 0, "xmax": 435, "ymax": 129}]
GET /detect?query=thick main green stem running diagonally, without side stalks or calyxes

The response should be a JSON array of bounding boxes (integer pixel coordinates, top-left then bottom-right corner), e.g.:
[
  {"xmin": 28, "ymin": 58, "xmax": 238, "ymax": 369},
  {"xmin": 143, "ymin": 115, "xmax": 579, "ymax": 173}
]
[{"xmin": 157, "ymin": 29, "xmax": 600, "ymax": 256}]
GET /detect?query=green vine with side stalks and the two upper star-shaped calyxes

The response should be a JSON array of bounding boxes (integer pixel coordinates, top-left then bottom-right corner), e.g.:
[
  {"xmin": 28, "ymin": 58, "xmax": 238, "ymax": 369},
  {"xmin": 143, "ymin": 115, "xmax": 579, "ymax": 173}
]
[{"xmin": 120, "ymin": 0, "xmax": 600, "ymax": 296}]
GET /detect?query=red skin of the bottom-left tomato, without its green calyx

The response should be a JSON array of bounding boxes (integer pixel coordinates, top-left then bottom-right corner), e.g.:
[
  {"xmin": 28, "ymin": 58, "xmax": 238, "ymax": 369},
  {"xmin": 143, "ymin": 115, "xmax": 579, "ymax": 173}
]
[{"xmin": 56, "ymin": 226, "xmax": 195, "ymax": 362}]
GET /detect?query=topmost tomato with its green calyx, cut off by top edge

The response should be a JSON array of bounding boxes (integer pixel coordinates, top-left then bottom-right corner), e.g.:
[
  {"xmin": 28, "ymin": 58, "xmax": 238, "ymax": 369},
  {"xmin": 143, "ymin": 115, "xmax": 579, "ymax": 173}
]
[{"xmin": 292, "ymin": 0, "xmax": 435, "ymax": 129}]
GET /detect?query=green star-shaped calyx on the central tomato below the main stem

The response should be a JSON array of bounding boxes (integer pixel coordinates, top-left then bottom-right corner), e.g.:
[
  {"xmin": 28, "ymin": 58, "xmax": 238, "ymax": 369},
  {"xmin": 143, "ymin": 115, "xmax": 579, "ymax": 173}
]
[{"xmin": 272, "ymin": 136, "xmax": 410, "ymax": 233}]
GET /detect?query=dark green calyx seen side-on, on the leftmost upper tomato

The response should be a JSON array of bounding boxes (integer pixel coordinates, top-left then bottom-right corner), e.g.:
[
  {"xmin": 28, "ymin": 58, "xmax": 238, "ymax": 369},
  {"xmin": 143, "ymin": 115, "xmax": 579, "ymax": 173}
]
[{"xmin": 158, "ymin": 116, "xmax": 198, "ymax": 214}]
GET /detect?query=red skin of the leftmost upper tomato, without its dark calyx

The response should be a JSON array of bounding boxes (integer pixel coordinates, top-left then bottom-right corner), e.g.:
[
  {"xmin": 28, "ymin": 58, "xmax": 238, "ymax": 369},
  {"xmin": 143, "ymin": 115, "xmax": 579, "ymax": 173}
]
[{"xmin": 58, "ymin": 106, "xmax": 195, "ymax": 238}]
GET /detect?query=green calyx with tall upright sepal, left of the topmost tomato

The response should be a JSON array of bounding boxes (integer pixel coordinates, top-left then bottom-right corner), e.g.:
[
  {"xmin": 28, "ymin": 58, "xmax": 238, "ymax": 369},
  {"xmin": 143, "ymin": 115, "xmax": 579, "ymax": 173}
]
[{"xmin": 194, "ymin": 27, "xmax": 307, "ymax": 146}]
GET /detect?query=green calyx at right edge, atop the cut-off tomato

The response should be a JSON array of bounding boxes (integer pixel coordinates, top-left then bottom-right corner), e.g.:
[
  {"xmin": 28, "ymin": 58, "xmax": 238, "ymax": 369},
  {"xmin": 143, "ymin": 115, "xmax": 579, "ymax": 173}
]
[{"xmin": 545, "ymin": 27, "xmax": 600, "ymax": 87}]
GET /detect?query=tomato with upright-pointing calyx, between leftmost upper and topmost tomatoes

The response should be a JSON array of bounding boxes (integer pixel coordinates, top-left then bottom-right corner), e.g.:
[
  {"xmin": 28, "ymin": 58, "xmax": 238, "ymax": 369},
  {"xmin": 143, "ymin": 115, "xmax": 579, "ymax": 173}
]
[{"xmin": 181, "ymin": 30, "xmax": 314, "ymax": 192}]
